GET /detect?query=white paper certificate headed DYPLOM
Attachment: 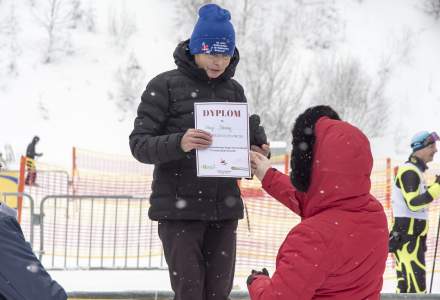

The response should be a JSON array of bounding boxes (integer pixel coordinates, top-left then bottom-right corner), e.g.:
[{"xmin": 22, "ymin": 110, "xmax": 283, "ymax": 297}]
[{"xmin": 194, "ymin": 102, "xmax": 251, "ymax": 177}]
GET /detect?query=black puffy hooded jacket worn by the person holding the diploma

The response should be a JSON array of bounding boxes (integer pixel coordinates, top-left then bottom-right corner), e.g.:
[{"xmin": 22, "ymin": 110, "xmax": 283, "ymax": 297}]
[{"xmin": 130, "ymin": 41, "xmax": 246, "ymax": 220}]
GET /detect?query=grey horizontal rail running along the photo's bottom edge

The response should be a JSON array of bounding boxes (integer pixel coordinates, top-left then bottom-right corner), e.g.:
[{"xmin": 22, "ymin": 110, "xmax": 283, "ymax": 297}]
[{"xmin": 69, "ymin": 291, "xmax": 440, "ymax": 300}]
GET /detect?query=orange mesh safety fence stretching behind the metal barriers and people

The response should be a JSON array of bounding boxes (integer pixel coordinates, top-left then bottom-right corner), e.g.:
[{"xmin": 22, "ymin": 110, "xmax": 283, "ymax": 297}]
[{"xmin": 16, "ymin": 149, "xmax": 440, "ymax": 278}]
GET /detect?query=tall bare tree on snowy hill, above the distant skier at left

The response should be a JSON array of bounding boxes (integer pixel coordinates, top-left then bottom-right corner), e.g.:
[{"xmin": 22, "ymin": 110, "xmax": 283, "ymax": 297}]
[{"xmin": 33, "ymin": 0, "xmax": 74, "ymax": 63}]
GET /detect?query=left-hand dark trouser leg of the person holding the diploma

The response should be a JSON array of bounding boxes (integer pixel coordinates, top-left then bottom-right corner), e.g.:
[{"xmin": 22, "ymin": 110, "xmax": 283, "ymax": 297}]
[{"xmin": 158, "ymin": 220, "xmax": 206, "ymax": 300}]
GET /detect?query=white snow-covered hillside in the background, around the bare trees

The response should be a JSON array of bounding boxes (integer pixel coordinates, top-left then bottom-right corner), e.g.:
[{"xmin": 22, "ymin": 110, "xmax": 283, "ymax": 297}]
[{"xmin": 0, "ymin": 0, "xmax": 440, "ymax": 167}]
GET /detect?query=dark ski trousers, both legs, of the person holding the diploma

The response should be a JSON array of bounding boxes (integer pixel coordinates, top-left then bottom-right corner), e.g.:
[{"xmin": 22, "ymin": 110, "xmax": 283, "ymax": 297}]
[{"xmin": 158, "ymin": 220, "xmax": 238, "ymax": 300}]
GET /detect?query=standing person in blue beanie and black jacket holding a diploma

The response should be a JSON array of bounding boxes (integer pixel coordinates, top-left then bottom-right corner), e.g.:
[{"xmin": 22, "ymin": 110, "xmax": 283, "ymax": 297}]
[{"xmin": 130, "ymin": 4, "xmax": 269, "ymax": 300}]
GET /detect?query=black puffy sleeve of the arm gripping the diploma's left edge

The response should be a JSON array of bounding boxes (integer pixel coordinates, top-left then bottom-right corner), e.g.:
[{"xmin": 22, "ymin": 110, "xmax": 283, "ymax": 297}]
[{"xmin": 129, "ymin": 74, "xmax": 185, "ymax": 164}]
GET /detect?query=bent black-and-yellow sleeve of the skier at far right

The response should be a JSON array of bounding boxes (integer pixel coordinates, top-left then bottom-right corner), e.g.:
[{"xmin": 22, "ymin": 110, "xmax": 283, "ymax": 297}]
[{"xmin": 400, "ymin": 170, "xmax": 434, "ymax": 211}]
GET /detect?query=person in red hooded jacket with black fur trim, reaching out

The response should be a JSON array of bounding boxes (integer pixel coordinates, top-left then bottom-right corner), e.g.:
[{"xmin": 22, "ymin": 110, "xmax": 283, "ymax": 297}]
[{"xmin": 247, "ymin": 106, "xmax": 388, "ymax": 300}]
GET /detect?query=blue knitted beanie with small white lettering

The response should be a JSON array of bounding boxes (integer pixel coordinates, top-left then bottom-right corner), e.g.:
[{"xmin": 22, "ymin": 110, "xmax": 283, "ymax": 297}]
[{"xmin": 189, "ymin": 4, "xmax": 235, "ymax": 56}]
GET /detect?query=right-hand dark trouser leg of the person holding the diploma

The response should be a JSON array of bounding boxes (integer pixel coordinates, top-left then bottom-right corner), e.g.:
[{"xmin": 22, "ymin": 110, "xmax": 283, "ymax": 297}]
[{"xmin": 203, "ymin": 220, "xmax": 238, "ymax": 300}]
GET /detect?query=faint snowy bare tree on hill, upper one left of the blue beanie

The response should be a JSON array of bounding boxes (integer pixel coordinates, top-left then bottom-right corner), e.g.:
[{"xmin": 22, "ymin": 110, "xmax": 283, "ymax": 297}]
[{"xmin": 108, "ymin": 5, "xmax": 137, "ymax": 48}]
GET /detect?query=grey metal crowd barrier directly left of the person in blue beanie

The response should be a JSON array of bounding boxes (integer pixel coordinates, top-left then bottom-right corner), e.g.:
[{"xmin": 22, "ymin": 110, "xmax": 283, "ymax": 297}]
[{"xmin": 39, "ymin": 195, "xmax": 165, "ymax": 270}]
